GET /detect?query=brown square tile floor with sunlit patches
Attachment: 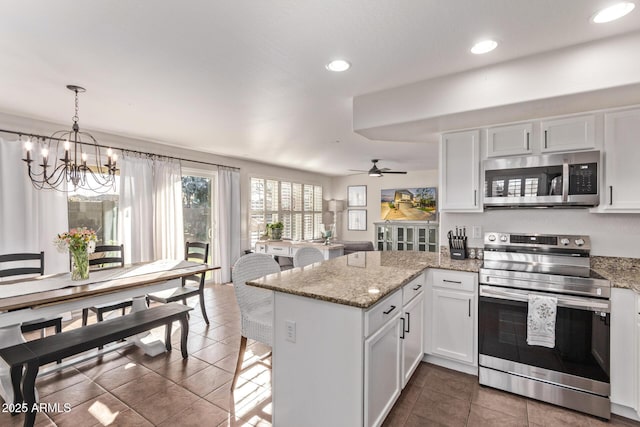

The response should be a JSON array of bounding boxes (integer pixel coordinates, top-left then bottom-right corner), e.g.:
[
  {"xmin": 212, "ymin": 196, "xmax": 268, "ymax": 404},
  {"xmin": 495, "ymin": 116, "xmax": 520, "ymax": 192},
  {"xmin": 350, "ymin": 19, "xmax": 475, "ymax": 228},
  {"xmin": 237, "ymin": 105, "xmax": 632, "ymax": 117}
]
[{"xmin": 0, "ymin": 285, "xmax": 640, "ymax": 427}]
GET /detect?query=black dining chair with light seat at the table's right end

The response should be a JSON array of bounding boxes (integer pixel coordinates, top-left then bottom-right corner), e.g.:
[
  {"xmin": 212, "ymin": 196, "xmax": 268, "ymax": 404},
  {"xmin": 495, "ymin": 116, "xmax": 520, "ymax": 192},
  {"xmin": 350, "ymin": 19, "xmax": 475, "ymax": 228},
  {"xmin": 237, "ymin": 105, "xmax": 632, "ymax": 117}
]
[{"xmin": 147, "ymin": 242, "xmax": 209, "ymax": 325}]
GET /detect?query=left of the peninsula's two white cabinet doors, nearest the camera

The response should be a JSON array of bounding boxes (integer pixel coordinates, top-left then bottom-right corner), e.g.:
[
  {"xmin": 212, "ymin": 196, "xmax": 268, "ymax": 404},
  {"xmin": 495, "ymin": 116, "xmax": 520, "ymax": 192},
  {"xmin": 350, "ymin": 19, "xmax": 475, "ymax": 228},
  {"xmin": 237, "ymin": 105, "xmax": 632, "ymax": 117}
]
[{"xmin": 364, "ymin": 304, "xmax": 402, "ymax": 426}]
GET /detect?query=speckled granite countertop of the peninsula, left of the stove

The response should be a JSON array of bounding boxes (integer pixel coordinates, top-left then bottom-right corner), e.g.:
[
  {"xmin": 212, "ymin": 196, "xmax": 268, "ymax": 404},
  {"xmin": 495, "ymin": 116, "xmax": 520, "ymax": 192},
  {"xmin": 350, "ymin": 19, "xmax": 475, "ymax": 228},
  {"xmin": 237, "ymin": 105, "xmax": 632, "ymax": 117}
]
[{"xmin": 247, "ymin": 251, "xmax": 481, "ymax": 308}]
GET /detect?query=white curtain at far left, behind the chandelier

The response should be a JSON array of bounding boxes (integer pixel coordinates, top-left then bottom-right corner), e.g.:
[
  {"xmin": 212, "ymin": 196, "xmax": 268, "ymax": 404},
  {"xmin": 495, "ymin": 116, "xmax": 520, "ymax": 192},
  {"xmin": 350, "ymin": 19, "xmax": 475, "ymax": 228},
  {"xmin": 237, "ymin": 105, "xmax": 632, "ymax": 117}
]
[{"xmin": 0, "ymin": 139, "xmax": 69, "ymax": 274}]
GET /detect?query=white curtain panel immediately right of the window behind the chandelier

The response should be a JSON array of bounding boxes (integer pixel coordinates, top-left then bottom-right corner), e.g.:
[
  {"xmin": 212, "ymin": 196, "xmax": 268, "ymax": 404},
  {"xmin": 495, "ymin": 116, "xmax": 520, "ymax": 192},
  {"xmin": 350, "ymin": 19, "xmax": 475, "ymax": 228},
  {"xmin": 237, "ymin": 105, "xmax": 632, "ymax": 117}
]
[{"xmin": 118, "ymin": 154, "xmax": 154, "ymax": 264}]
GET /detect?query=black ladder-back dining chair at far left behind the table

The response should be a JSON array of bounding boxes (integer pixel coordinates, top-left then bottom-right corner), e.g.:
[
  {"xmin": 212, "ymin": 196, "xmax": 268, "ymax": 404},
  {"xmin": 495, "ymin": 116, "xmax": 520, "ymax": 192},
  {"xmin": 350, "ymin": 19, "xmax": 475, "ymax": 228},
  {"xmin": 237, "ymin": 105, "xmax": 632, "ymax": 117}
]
[{"xmin": 0, "ymin": 252, "xmax": 62, "ymax": 337}]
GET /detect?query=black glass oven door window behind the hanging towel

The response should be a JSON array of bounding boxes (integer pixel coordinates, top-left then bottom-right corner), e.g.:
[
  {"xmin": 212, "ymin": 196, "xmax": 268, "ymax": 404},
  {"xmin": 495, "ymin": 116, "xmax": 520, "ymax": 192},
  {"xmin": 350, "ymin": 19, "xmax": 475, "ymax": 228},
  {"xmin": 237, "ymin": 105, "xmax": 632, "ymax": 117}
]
[{"xmin": 478, "ymin": 297, "xmax": 610, "ymax": 382}]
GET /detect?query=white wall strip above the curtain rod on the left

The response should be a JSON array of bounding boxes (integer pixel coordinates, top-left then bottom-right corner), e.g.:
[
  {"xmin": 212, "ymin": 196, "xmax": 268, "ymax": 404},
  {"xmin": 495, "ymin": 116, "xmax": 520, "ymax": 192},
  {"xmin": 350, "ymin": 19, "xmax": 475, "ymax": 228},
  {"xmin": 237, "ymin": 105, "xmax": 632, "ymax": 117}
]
[{"xmin": 0, "ymin": 113, "xmax": 331, "ymax": 256}]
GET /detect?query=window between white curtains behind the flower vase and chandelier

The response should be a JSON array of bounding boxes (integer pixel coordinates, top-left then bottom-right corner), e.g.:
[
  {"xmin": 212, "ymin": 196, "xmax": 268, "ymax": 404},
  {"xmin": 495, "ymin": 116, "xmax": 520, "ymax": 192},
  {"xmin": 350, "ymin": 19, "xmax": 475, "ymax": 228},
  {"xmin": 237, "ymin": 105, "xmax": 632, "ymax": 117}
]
[{"xmin": 67, "ymin": 176, "xmax": 120, "ymax": 245}]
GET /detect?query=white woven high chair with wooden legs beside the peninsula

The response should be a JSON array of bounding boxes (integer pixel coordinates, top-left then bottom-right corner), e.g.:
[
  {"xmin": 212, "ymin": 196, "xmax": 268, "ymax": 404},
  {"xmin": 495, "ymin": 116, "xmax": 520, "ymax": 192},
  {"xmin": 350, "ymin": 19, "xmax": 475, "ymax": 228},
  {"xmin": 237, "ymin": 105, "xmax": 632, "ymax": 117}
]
[{"xmin": 231, "ymin": 254, "xmax": 280, "ymax": 390}]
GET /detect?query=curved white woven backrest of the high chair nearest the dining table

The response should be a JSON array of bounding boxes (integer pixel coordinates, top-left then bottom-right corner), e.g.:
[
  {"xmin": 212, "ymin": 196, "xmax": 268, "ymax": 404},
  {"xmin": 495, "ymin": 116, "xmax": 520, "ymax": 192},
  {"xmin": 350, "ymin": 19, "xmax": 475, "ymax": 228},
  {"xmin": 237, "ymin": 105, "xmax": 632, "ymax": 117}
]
[{"xmin": 231, "ymin": 254, "xmax": 280, "ymax": 326}]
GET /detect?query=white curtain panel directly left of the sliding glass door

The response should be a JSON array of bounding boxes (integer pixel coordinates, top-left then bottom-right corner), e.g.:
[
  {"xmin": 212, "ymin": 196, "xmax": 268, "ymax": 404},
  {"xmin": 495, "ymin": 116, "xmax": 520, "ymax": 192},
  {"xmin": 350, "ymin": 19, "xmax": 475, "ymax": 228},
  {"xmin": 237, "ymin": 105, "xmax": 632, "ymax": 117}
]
[{"xmin": 153, "ymin": 160, "xmax": 184, "ymax": 259}]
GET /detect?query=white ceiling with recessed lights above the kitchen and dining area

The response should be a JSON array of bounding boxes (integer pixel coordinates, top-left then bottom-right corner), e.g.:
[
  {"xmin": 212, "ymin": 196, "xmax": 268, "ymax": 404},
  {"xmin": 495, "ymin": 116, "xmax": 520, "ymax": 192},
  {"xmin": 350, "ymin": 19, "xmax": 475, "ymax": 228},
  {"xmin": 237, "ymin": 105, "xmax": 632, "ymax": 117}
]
[{"xmin": 0, "ymin": 0, "xmax": 640, "ymax": 175}]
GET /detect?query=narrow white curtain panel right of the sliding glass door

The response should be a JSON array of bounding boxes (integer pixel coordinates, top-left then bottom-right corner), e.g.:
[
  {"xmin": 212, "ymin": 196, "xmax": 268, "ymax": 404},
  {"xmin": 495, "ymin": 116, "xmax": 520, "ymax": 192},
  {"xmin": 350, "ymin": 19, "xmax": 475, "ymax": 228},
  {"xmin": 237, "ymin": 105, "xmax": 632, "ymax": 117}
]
[{"xmin": 215, "ymin": 167, "xmax": 241, "ymax": 283}]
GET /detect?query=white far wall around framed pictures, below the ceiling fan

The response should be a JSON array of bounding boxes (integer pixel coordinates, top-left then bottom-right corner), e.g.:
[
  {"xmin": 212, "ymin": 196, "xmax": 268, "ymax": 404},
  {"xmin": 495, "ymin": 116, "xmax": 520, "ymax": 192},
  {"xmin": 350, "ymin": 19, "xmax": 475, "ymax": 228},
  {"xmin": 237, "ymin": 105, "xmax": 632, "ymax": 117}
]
[{"xmin": 331, "ymin": 170, "xmax": 438, "ymax": 242}]
